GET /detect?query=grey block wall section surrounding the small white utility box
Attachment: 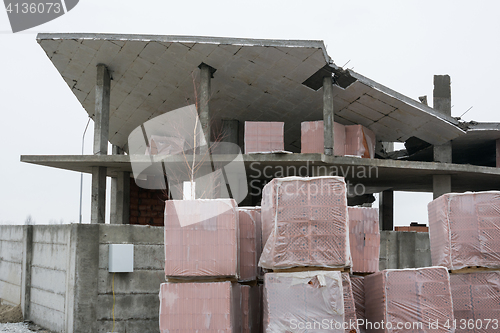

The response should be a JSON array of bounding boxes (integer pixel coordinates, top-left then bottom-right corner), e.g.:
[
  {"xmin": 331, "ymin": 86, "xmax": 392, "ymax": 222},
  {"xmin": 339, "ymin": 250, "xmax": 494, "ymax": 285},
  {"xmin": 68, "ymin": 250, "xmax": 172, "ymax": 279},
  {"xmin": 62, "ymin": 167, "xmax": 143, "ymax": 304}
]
[{"xmin": 96, "ymin": 225, "xmax": 165, "ymax": 332}]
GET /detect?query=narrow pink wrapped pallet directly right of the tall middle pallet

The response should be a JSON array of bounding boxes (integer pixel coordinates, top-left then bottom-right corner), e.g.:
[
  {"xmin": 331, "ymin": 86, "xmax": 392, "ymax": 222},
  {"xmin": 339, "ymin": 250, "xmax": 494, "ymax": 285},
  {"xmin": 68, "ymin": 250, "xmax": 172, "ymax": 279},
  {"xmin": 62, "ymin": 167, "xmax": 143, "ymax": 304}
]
[{"xmin": 349, "ymin": 207, "xmax": 380, "ymax": 273}]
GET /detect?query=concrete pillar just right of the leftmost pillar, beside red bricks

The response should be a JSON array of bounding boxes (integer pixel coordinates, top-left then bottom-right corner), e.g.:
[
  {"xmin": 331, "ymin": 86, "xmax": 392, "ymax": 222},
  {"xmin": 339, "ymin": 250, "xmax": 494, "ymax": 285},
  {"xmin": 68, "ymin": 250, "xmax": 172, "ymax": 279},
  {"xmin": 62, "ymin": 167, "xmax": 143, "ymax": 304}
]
[{"xmin": 109, "ymin": 145, "xmax": 130, "ymax": 224}]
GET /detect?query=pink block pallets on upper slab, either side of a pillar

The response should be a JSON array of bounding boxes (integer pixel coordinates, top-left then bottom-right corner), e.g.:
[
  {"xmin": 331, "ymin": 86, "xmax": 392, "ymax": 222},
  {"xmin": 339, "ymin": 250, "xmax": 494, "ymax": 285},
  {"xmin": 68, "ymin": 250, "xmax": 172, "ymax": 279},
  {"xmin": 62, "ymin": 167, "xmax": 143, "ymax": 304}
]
[{"xmin": 301, "ymin": 120, "xmax": 376, "ymax": 158}]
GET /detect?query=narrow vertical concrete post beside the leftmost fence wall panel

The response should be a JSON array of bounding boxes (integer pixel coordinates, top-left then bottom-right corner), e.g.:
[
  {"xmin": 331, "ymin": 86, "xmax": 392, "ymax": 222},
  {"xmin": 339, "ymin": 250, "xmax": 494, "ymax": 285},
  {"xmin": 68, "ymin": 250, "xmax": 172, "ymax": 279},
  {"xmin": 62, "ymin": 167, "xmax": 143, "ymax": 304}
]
[{"xmin": 21, "ymin": 225, "xmax": 33, "ymax": 320}]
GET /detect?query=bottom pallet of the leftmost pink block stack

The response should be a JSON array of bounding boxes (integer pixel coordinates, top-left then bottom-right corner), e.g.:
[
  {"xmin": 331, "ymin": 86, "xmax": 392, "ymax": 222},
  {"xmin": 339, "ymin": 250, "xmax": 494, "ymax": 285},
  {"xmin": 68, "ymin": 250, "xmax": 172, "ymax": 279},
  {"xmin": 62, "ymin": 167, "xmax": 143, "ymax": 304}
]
[{"xmin": 160, "ymin": 282, "xmax": 241, "ymax": 333}]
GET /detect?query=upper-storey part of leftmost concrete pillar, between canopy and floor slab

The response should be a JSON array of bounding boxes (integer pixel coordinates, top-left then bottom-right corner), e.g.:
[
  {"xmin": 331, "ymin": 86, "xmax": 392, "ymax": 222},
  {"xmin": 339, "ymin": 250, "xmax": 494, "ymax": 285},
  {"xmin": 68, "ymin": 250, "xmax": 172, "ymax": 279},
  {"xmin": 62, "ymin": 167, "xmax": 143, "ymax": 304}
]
[{"xmin": 94, "ymin": 64, "xmax": 111, "ymax": 155}]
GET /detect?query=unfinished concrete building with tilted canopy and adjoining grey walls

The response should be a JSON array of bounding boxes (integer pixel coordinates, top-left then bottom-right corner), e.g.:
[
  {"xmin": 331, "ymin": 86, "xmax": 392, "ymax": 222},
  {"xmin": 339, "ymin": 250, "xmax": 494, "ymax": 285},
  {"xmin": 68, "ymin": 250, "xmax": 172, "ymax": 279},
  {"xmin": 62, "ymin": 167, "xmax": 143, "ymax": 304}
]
[{"xmin": 0, "ymin": 34, "xmax": 500, "ymax": 332}]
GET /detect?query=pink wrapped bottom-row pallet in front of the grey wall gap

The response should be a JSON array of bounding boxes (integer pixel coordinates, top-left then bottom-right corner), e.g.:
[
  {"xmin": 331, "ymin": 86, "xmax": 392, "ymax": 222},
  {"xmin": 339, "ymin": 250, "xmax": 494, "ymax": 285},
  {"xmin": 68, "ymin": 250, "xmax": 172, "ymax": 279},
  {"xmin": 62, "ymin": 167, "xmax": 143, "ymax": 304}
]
[{"xmin": 365, "ymin": 267, "xmax": 455, "ymax": 333}]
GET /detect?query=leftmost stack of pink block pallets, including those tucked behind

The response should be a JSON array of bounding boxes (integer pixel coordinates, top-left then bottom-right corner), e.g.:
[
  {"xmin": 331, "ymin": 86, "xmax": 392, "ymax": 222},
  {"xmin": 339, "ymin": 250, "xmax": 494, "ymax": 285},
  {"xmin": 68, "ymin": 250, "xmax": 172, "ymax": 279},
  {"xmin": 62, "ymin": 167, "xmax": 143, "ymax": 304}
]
[{"xmin": 160, "ymin": 199, "xmax": 261, "ymax": 333}]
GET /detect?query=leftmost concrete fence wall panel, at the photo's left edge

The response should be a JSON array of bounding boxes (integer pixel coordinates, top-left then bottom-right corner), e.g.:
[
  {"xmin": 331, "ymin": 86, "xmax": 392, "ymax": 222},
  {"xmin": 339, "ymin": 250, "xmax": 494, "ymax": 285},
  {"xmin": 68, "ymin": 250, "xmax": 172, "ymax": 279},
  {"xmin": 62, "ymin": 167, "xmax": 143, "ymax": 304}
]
[{"xmin": 0, "ymin": 225, "xmax": 26, "ymax": 305}]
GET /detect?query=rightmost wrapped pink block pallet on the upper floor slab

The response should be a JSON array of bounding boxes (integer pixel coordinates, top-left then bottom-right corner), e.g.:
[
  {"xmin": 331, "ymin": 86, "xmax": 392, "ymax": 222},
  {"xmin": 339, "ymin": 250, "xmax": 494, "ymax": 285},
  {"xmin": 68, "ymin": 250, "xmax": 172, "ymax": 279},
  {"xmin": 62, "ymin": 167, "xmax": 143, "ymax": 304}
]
[{"xmin": 345, "ymin": 125, "xmax": 376, "ymax": 158}]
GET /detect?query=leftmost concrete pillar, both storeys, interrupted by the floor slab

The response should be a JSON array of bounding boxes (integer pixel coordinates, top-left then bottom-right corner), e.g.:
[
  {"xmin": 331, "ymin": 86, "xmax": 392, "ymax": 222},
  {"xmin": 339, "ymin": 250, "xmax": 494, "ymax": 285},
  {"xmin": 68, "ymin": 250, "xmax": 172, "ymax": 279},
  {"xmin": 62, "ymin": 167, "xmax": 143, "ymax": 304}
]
[{"xmin": 90, "ymin": 64, "xmax": 110, "ymax": 223}]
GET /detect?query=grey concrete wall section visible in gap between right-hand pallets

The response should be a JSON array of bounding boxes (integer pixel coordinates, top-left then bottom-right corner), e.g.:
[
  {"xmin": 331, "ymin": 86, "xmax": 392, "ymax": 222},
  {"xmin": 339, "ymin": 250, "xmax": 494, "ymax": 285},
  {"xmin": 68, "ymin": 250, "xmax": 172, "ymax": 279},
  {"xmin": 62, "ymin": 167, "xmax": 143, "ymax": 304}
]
[{"xmin": 379, "ymin": 231, "xmax": 432, "ymax": 270}]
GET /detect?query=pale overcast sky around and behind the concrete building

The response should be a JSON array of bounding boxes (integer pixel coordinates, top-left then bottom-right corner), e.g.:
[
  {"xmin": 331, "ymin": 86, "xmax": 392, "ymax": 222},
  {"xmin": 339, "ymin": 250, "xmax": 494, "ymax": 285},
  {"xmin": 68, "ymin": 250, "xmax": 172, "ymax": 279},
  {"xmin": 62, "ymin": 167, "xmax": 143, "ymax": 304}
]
[{"xmin": 0, "ymin": 0, "xmax": 500, "ymax": 225}]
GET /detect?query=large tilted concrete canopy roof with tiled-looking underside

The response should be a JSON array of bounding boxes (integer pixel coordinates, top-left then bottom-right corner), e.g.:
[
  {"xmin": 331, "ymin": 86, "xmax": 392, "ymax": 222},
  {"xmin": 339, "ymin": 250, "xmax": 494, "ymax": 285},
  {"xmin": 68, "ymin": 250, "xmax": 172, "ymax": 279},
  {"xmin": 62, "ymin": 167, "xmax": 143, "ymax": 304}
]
[{"xmin": 37, "ymin": 34, "xmax": 464, "ymax": 151}]
